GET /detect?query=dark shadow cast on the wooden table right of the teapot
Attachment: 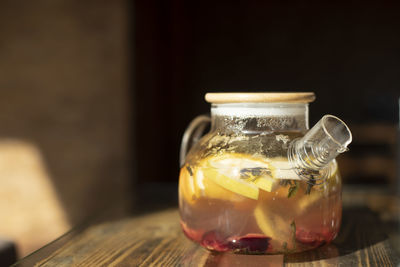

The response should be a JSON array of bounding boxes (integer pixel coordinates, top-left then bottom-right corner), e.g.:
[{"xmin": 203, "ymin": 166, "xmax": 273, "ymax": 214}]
[{"xmin": 285, "ymin": 207, "xmax": 397, "ymax": 264}]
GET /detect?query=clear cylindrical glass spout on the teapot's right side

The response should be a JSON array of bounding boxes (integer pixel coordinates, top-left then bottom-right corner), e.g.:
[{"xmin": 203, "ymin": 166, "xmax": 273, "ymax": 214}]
[{"xmin": 288, "ymin": 115, "xmax": 352, "ymax": 180}]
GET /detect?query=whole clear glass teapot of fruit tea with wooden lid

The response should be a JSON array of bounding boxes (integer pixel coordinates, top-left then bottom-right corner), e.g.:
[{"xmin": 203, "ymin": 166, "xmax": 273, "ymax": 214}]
[{"xmin": 179, "ymin": 93, "xmax": 352, "ymax": 254}]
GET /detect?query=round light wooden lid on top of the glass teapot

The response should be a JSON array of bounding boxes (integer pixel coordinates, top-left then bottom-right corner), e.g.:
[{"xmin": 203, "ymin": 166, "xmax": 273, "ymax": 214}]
[{"xmin": 205, "ymin": 92, "xmax": 315, "ymax": 104}]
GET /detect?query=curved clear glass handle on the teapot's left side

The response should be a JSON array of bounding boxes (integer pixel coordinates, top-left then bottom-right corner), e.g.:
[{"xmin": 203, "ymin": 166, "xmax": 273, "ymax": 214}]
[{"xmin": 179, "ymin": 115, "xmax": 211, "ymax": 167}]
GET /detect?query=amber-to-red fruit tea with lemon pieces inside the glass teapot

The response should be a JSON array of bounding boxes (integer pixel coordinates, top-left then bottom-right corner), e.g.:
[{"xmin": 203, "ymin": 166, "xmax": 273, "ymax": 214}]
[{"xmin": 179, "ymin": 153, "xmax": 341, "ymax": 254}]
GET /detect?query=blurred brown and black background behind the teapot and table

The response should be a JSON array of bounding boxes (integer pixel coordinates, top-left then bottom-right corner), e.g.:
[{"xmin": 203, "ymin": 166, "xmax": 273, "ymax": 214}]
[{"xmin": 0, "ymin": 0, "xmax": 400, "ymax": 264}]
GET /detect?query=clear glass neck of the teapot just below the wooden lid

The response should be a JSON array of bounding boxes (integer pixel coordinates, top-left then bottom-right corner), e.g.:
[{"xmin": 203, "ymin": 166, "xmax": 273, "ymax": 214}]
[{"xmin": 211, "ymin": 103, "xmax": 308, "ymax": 134}]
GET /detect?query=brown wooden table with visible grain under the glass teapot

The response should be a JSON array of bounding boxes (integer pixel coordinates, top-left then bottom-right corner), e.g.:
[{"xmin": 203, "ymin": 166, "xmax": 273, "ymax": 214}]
[{"xmin": 10, "ymin": 187, "xmax": 400, "ymax": 266}]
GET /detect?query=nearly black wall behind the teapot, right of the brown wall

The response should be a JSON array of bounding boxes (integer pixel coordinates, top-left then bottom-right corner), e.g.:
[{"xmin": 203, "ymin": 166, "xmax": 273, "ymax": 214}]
[{"xmin": 135, "ymin": 0, "xmax": 400, "ymax": 184}]
